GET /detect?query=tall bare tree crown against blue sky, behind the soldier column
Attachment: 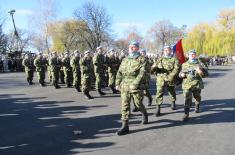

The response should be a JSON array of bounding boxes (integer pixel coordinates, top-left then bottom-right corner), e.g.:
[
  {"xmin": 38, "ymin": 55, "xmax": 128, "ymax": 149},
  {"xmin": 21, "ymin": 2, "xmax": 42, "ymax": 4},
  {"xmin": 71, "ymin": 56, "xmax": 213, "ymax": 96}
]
[{"xmin": 74, "ymin": 2, "xmax": 111, "ymax": 50}]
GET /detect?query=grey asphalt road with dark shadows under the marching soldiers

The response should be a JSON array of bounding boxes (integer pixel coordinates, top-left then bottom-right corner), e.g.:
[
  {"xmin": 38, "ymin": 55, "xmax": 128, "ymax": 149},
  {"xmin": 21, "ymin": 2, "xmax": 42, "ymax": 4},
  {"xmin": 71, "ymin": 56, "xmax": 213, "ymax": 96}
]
[{"xmin": 0, "ymin": 65, "xmax": 235, "ymax": 155}]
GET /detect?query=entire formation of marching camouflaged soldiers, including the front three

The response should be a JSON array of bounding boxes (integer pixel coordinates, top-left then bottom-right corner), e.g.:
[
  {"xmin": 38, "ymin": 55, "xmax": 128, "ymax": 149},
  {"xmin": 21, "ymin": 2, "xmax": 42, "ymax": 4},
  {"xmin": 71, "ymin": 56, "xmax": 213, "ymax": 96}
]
[{"xmin": 22, "ymin": 41, "xmax": 208, "ymax": 135}]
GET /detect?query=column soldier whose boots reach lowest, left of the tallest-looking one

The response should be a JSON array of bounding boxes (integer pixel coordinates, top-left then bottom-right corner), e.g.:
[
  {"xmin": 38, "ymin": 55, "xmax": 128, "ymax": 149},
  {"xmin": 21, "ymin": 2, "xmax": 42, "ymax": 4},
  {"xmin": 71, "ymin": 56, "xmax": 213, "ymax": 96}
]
[{"xmin": 79, "ymin": 51, "xmax": 93, "ymax": 99}]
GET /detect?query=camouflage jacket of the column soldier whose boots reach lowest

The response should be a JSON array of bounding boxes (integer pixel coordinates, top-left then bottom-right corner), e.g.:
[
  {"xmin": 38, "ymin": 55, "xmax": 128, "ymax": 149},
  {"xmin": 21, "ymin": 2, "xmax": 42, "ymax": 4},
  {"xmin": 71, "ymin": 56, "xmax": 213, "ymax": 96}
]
[{"xmin": 80, "ymin": 57, "xmax": 93, "ymax": 78}]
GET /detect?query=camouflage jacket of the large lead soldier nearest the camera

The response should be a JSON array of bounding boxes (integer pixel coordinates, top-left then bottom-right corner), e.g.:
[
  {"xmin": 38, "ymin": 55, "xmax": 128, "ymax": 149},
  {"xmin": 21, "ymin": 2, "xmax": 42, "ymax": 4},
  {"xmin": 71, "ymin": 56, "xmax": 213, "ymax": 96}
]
[{"xmin": 116, "ymin": 56, "xmax": 147, "ymax": 92}]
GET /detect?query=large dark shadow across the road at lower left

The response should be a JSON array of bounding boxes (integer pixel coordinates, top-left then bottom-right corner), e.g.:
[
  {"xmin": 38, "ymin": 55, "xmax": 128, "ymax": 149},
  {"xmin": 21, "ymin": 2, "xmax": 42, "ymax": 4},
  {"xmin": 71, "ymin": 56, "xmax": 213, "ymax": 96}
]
[{"xmin": 0, "ymin": 94, "xmax": 120, "ymax": 155}]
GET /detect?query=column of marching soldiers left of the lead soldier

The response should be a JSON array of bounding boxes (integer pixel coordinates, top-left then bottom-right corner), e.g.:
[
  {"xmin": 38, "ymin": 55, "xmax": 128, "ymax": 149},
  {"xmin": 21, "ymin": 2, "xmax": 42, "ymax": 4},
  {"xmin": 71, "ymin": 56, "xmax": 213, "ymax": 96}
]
[{"xmin": 22, "ymin": 46, "xmax": 123, "ymax": 99}]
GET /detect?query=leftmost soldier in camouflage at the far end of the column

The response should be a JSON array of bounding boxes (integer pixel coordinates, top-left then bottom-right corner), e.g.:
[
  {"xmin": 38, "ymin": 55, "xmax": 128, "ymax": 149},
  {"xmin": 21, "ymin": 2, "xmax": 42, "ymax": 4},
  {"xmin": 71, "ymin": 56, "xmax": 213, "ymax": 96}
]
[{"xmin": 22, "ymin": 54, "xmax": 35, "ymax": 85}]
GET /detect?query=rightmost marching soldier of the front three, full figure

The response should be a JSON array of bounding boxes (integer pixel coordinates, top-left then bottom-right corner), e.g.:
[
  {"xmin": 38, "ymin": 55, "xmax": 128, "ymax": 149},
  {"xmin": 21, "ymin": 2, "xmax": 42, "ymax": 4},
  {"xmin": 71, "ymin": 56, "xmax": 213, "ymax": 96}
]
[{"xmin": 179, "ymin": 50, "xmax": 206, "ymax": 121}]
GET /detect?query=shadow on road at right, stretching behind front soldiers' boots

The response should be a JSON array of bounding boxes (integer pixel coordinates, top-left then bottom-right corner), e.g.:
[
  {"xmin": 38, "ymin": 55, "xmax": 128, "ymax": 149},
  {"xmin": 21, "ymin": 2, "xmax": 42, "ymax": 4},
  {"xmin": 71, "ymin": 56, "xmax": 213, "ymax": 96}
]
[{"xmin": 131, "ymin": 99, "xmax": 235, "ymax": 133}]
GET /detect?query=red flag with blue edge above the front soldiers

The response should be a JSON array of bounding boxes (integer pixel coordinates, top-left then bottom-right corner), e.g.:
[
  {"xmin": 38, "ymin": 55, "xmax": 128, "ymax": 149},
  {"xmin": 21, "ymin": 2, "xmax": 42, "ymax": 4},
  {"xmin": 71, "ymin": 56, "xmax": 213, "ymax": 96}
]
[{"xmin": 173, "ymin": 39, "xmax": 186, "ymax": 64}]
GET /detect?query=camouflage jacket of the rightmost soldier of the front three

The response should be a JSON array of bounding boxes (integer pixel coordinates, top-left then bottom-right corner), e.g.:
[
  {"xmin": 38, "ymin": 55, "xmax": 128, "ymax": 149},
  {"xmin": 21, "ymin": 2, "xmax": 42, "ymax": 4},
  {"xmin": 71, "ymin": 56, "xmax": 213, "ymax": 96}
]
[{"xmin": 180, "ymin": 61, "xmax": 205, "ymax": 89}]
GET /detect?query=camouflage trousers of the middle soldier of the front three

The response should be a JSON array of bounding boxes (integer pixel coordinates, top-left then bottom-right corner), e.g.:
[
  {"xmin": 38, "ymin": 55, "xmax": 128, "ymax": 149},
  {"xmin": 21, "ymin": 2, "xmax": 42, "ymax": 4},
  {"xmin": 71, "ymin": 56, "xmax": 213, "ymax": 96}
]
[{"xmin": 156, "ymin": 78, "xmax": 176, "ymax": 105}]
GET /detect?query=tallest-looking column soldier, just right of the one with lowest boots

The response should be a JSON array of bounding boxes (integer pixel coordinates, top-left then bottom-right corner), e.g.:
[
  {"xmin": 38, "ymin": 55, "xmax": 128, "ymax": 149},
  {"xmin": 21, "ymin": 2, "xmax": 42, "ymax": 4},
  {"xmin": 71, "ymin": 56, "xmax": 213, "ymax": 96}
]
[{"xmin": 93, "ymin": 46, "xmax": 106, "ymax": 95}]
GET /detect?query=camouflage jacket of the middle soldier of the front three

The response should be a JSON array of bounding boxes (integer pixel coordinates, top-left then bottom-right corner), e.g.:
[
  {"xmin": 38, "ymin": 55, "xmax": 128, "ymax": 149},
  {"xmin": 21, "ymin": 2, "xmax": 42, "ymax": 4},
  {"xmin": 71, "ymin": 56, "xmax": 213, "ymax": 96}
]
[{"xmin": 151, "ymin": 57, "xmax": 180, "ymax": 83}]
